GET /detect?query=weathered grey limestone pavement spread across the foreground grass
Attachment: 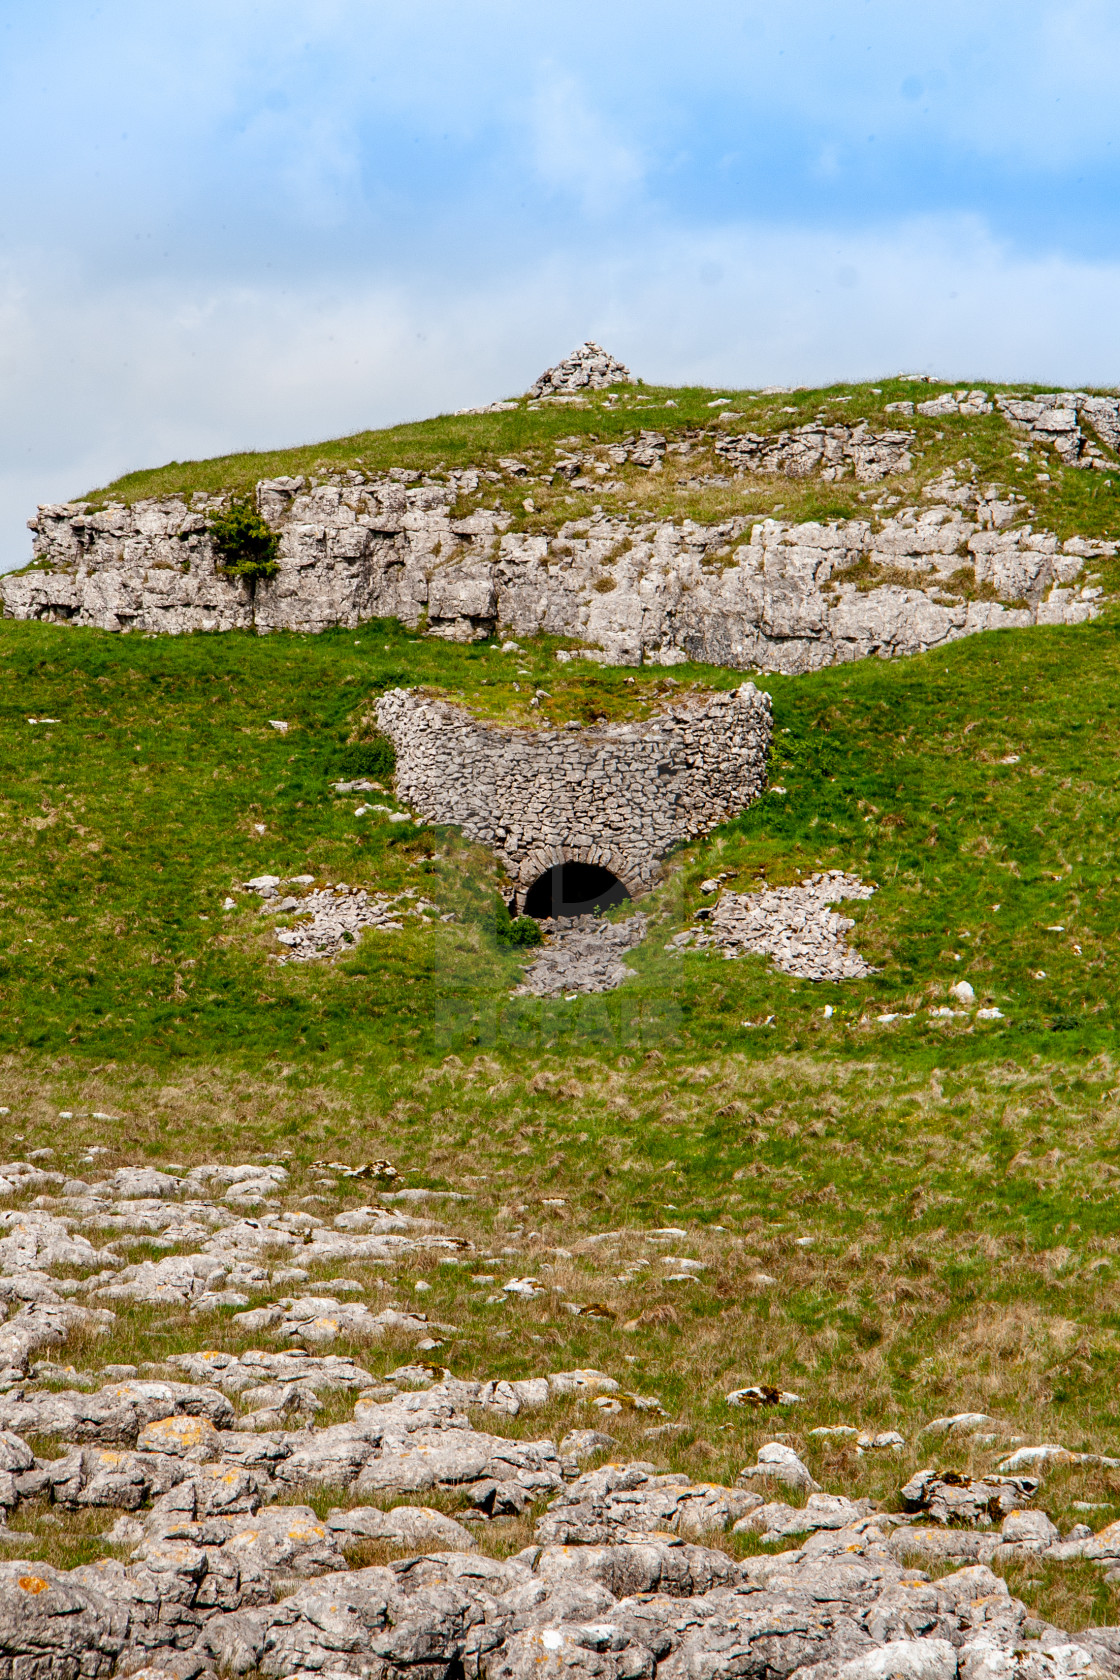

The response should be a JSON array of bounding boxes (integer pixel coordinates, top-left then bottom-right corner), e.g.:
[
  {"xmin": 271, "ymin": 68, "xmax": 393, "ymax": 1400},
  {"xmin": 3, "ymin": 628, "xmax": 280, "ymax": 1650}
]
[{"xmin": 0, "ymin": 1161, "xmax": 1120, "ymax": 1680}]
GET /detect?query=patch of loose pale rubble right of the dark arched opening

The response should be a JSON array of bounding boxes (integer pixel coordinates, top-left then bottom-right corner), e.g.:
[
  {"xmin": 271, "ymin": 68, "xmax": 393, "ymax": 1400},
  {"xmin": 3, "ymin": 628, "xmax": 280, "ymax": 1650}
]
[{"xmin": 668, "ymin": 869, "xmax": 877, "ymax": 979}]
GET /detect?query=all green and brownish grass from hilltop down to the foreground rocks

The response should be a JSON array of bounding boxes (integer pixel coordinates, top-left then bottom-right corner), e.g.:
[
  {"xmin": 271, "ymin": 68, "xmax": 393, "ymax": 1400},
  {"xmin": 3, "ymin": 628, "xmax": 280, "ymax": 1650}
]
[{"xmin": 0, "ymin": 383, "xmax": 1120, "ymax": 1626}]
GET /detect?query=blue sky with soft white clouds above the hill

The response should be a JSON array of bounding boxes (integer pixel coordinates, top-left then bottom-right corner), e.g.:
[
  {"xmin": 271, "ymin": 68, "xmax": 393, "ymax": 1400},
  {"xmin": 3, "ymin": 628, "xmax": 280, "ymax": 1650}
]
[{"xmin": 0, "ymin": 0, "xmax": 1120, "ymax": 570}]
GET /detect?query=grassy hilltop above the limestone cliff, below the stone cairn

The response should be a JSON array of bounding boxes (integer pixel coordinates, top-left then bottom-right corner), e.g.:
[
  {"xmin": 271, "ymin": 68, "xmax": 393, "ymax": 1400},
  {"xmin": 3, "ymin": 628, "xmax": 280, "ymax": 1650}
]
[{"xmin": 65, "ymin": 380, "xmax": 1120, "ymax": 557}]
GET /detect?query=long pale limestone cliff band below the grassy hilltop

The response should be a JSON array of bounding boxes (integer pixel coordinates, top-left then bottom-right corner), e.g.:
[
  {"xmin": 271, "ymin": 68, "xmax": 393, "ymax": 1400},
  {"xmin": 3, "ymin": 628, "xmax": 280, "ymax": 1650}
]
[{"xmin": 0, "ymin": 469, "xmax": 1112, "ymax": 674}]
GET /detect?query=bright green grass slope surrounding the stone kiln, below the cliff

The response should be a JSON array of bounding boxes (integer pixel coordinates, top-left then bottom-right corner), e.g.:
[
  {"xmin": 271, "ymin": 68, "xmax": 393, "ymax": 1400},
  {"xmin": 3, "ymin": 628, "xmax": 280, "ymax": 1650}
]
[{"xmin": 0, "ymin": 618, "xmax": 1120, "ymax": 1077}]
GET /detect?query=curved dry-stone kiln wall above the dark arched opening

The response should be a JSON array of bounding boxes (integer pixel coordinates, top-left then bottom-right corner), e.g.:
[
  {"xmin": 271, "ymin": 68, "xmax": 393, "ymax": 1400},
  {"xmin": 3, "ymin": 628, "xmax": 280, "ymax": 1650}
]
[{"xmin": 376, "ymin": 682, "xmax": 771, "ymax": 907}]
